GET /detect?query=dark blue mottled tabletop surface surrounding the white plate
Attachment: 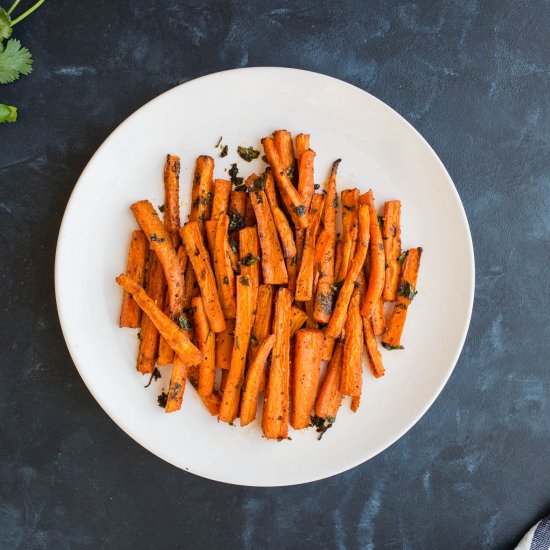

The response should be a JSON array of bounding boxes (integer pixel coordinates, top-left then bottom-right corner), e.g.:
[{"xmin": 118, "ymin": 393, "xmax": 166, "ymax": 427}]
[{"xmin": 0, "ymin": 0, "xmax": 550, "ymax": 549}]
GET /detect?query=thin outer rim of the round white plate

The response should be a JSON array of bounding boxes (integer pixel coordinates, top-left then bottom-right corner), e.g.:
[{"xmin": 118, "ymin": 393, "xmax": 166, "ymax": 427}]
[{"xmin": 54, "ymin": 66, "xmax": 476, "ymax": 487}]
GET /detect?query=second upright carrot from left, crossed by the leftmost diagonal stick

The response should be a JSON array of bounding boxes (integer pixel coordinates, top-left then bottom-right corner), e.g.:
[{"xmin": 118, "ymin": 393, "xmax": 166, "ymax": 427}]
[{"xmin": 137, "ymin": 254, "xmax": 166, "ymax": 374}]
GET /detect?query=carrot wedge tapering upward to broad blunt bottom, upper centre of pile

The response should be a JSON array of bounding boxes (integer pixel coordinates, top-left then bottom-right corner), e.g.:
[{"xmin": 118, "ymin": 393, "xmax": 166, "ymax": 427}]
[{"xmin": 246, "ymin": 174, "xmax": 288, "ymax": 285}]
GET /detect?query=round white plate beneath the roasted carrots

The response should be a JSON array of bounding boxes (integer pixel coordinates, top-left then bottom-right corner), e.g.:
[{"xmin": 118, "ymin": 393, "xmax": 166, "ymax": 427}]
[{"xmin": 55, "ymin": 68, "xmax": 474, "ymax": 486}]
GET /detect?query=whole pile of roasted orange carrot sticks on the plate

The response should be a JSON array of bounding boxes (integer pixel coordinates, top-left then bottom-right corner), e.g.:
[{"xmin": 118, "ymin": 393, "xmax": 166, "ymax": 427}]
[{"xmin": 116, "ymin": 130, "xmax": 422, "ymax": 440}]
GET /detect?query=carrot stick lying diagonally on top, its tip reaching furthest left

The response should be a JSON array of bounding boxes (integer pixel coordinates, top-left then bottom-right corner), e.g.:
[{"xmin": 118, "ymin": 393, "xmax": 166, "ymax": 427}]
[{"xmin": 116, "ymin": 274, "xmax": 202, "ymax": 365}]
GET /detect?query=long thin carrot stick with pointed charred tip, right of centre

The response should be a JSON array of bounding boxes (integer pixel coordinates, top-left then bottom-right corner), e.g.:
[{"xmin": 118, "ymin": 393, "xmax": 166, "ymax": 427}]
[{"xmin": 314, "ymin": 160, "xmax": 340, "ymax": 323}]
